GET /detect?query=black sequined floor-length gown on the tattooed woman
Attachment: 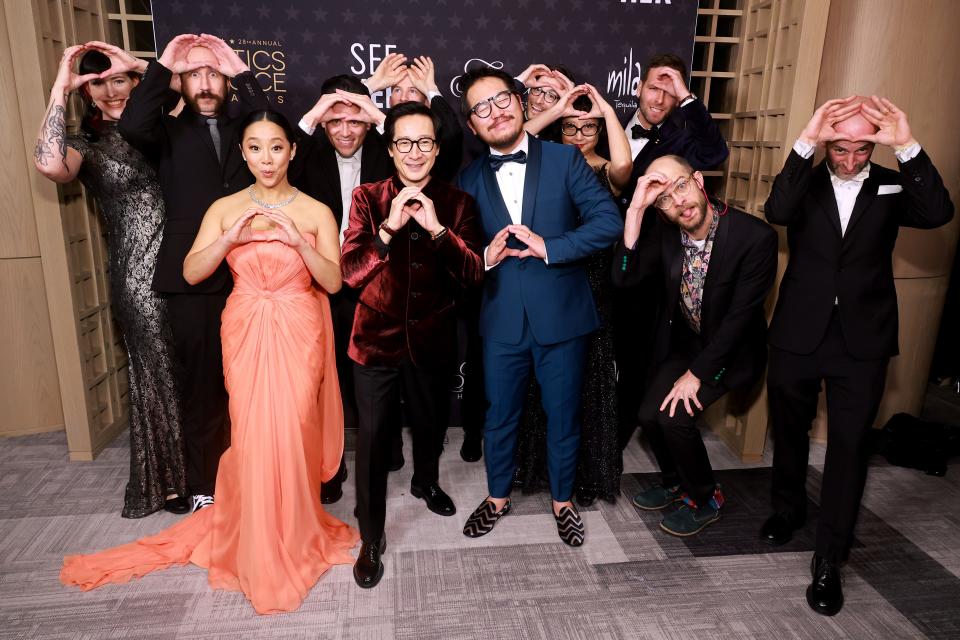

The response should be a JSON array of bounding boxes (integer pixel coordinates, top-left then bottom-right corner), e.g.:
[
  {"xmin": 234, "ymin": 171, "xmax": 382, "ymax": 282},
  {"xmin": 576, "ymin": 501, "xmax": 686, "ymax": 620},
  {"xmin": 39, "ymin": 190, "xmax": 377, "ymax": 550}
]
[{"xmin": 67, "ymin": 122, "xmax": 186, "ymax": 518}]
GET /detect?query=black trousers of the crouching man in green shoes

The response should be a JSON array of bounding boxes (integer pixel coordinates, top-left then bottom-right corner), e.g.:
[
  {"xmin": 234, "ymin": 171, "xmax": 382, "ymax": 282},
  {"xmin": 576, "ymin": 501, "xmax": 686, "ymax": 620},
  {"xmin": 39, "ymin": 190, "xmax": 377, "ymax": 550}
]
[{"xmin": 639, "ymin": 350, "xmax": 727, "ymax": 505}]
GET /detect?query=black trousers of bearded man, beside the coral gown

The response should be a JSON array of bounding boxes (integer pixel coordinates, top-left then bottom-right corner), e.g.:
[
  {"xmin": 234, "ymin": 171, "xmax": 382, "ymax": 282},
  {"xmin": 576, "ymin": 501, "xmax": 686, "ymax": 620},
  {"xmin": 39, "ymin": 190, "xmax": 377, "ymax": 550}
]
[{"xmin": 167, "ymin": 293, "xmax": 230, "ymax": 495}]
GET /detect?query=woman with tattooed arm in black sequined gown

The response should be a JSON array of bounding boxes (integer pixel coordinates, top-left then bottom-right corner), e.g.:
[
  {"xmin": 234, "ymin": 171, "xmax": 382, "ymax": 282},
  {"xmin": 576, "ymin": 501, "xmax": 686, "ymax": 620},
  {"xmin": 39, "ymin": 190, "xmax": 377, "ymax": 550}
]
[{"xmin": 34, "ymin": 43, "xmax": 186, "ymax": 518}]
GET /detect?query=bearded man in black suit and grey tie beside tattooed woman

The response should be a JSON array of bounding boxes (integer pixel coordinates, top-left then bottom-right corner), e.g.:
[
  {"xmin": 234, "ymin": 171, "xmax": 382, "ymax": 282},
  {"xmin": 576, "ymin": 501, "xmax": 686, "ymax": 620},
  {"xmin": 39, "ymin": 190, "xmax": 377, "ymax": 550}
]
[{"xmin": 118, "ymin": 35, "xmax": 269, "ymax": 513}]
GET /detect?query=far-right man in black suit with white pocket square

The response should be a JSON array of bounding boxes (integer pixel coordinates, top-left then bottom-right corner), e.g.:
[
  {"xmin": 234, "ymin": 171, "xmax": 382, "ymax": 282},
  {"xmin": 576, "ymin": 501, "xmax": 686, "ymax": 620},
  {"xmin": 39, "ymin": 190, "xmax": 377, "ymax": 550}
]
[{"xmin": 760, "ymin": 96, "xmax": 953, "ymax": 615}]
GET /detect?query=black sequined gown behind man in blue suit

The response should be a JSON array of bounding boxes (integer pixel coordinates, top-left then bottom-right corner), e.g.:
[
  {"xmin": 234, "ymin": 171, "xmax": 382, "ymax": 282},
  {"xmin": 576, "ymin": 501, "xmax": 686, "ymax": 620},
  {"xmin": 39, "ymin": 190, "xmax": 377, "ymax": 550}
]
[{"xmin": 514, "ymin": 164, "xmax": 623, "ymax": 504}]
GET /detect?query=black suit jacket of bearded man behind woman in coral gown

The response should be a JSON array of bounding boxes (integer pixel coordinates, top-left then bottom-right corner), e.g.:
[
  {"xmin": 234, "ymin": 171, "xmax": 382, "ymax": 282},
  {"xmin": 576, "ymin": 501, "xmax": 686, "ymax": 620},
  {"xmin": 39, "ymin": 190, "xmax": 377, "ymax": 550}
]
[{"xmin": 118, "ymin": 61, "xmax": 269, "ymax": 293}]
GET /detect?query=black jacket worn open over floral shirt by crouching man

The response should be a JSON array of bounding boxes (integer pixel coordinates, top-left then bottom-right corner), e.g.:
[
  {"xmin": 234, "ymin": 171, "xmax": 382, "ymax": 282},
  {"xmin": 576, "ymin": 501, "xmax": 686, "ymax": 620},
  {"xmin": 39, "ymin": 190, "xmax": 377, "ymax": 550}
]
[{"xmin": 611, "ymin": 208, "xmax": 777, "ymax": 389}]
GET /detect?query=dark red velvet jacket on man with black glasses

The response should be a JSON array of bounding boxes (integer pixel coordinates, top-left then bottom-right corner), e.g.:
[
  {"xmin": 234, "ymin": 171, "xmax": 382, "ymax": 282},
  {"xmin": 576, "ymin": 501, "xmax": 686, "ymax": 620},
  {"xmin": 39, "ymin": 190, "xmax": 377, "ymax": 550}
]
[{"xmin": 340, "ymin": 176, "xmax": 484, "ymax": 370}]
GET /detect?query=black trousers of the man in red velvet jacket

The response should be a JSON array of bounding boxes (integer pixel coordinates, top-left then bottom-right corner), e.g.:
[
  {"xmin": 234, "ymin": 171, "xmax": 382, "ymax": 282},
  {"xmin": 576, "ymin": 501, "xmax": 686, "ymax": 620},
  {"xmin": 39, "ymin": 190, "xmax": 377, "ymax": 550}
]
[{"xmin": 353, "ymin": 362, "xmax": 450, "ymax": 542}]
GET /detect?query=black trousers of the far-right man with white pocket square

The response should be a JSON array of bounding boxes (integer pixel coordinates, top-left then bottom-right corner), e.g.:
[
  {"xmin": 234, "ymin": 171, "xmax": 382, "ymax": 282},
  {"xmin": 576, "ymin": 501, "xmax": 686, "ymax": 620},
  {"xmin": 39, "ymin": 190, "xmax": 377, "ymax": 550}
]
[{"xmin": 767, "ymin": 313, "xmax": 889, "ymax": 562}]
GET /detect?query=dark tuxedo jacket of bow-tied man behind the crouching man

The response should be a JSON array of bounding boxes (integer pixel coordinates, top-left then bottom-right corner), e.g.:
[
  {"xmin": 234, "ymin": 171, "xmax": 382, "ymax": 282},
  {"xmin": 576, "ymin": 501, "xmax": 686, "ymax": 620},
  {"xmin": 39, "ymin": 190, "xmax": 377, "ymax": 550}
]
[{"xmin": 619, "ymin": 98, "xmax": 730, "ymax": 210}]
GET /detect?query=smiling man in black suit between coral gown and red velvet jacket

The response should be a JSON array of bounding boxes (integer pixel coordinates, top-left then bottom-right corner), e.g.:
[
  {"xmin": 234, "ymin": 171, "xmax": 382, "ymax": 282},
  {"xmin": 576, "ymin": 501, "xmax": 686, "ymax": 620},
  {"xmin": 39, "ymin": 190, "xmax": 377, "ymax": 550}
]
[{"xmin": 291, "ymin": 75, "xmax": 403, "ymax": 504}]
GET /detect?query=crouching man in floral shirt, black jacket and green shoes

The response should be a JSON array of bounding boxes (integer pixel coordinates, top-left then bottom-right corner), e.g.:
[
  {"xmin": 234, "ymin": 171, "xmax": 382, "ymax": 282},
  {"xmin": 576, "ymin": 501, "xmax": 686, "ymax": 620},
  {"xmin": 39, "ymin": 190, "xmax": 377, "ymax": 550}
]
[{"xmin": 612, "ymin": 156, "xmax": 777, "ymax": 536}]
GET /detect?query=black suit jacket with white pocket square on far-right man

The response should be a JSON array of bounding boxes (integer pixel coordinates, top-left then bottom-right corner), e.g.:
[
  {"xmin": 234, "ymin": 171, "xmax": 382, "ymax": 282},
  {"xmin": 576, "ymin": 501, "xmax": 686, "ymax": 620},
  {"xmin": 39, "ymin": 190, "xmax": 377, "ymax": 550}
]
[{"xmin": 764, "ymin": 150, "xmax": 953, "ymax": 359}]
